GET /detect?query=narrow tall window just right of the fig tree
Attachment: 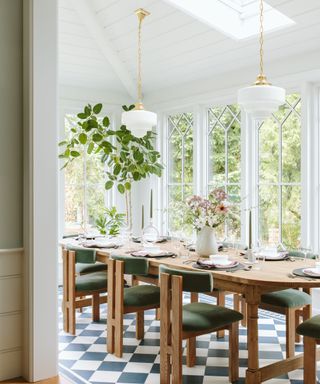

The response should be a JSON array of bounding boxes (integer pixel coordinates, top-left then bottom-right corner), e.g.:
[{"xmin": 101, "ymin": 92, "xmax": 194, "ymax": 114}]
[{"xmin": 167, "ymin": 113, "xmax": 193, "ymax": 232}]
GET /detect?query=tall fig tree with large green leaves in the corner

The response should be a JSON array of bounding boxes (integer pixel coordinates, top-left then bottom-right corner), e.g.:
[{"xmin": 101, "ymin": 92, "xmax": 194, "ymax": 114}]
[{"xmin": 59, "ymin": 104, "xmax": 163, "ymax": 229}]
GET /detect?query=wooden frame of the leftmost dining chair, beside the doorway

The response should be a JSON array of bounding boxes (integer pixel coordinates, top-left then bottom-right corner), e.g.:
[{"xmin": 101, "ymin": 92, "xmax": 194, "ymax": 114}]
[{"xmin": 62, "ymin": 249, "xmax": 108, "ymax": 335}]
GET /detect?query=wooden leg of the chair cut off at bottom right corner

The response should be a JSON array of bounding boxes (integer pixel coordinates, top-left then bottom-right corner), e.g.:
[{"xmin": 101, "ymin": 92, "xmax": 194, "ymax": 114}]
[{"xmin": 303, "ymin": 336, "xmax": 320, "ymax": 384}]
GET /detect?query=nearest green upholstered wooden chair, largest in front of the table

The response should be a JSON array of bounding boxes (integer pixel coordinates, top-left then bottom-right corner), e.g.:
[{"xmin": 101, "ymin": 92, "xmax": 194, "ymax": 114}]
[{"xmin": 160, "ymin": 265, "xmax": 242, "ymax": 384}]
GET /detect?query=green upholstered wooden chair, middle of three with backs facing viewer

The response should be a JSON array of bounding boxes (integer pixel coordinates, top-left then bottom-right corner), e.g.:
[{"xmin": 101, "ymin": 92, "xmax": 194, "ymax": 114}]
[{"xmin": 107, "ymin": 255, "xmax": 160, "ymax": 357}]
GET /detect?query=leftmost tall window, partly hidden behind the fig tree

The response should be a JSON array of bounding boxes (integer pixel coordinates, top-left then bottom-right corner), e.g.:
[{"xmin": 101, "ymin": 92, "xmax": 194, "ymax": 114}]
[{"xmin": 64, "ymin": 114, "xmax": 107, "ymax": 235}]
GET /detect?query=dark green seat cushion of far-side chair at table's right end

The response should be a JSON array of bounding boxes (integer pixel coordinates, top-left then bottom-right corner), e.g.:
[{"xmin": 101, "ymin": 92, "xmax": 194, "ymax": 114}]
[{"xmin": 261, "ymin": 289, "xmax": 311, "ymax": 308}]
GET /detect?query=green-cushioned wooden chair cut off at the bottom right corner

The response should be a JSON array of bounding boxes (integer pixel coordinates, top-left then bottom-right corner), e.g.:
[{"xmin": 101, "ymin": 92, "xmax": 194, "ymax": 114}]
[{"xmin": 297, "ymin": 315, "xmax": 320, "ymax": 384}]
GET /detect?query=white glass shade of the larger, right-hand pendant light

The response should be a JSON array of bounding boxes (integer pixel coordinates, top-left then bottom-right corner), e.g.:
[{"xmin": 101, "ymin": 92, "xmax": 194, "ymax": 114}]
[{"xmin": 238, "ymin": 85, "xmax": 286, "ymax": 120}]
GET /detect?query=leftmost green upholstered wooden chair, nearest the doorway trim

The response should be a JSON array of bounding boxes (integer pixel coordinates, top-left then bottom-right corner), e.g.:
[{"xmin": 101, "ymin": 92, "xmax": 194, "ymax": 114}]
[{"xmin": 62, "ymin": 248, "xmax": 107, "ymax": 335}]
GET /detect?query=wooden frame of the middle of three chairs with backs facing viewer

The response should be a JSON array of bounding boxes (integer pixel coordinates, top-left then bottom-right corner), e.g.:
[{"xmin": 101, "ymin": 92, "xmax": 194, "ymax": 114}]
[{"xmin": 107, "ymin": 259, "xmax": 160, "ymax": 357}]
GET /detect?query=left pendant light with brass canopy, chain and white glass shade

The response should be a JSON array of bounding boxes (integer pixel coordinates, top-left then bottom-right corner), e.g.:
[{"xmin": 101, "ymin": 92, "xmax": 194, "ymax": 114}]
[{"xmin": 121, "ymin": 8, "xmax": 157, "ymax": 137}]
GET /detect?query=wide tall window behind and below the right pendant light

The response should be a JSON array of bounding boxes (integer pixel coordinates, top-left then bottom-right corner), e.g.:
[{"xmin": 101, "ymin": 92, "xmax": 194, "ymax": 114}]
[{"xmin": 258, "ymin": 94, "xmax": 301, "ymax": 247}]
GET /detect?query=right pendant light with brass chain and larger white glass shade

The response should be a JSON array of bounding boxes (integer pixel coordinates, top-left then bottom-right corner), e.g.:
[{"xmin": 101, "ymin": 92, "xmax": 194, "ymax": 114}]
[{"xmin": 238, "ymin": 0, "xmax": 286, "ymax": 120}]
